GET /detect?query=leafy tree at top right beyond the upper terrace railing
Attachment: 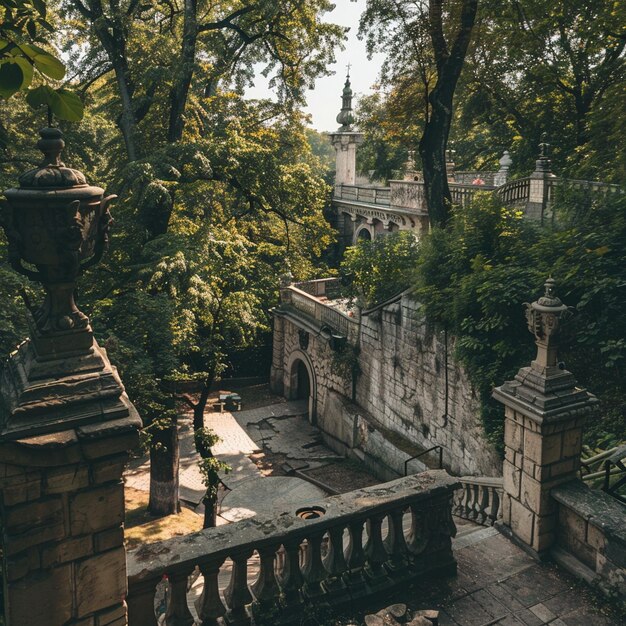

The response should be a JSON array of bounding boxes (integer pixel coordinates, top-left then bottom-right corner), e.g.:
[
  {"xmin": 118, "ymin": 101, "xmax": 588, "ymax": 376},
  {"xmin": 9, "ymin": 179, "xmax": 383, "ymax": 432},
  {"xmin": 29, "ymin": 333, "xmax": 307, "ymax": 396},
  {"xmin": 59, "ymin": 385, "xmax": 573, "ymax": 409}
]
[{"xmin": 448, "ymin": 0, "xmax": 626, "ymax": 181}]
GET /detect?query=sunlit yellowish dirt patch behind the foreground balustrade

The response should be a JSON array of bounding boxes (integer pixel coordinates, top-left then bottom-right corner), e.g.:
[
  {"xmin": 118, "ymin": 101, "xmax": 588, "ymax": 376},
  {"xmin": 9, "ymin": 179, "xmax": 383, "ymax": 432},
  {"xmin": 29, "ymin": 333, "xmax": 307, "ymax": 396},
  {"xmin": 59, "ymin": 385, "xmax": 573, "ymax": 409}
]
[{"xmin": 124, "ymin": 487, "xmax": 204, "ymax": 550}]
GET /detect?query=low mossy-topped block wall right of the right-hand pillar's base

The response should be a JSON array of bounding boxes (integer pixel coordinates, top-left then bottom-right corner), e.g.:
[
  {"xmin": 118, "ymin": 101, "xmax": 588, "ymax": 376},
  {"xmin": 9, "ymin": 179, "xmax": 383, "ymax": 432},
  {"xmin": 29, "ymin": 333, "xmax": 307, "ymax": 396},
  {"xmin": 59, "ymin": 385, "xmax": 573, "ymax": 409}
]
[{"xmin": 552, "ymin": 480, "xmax": 626, "ymax": 600}]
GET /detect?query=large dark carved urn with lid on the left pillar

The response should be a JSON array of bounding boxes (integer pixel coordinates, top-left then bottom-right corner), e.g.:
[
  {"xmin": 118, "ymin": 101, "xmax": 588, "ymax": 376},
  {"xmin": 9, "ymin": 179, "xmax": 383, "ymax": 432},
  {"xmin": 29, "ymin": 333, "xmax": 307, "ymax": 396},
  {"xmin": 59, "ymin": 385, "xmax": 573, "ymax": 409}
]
[{"xmin": 2, "ymin": 128, "xmax": 115, "ymax": 356}]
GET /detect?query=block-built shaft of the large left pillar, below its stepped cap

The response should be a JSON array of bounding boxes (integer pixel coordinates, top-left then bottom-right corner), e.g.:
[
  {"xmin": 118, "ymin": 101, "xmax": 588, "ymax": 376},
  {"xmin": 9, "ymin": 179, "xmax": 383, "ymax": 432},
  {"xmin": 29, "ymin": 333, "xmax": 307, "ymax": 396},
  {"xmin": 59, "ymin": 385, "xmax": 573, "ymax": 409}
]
[{"xmin": 0, "ymin": 415, "xmax": 140, "ymax": 626}]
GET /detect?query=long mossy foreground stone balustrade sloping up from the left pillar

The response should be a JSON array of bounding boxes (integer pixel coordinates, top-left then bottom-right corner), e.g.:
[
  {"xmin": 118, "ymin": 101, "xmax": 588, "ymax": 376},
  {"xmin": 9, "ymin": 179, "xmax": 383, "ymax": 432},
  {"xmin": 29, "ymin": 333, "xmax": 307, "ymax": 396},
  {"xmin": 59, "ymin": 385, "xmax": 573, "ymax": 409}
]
[{"xmin": 127, "ymin": 470, "xmax": 458, "ymax": 626}]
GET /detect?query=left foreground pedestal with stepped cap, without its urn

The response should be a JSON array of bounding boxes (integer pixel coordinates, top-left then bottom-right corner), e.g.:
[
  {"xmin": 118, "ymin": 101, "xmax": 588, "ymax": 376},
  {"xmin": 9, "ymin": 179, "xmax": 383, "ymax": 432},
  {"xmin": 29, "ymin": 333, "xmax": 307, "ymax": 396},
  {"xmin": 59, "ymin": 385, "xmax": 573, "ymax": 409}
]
[{"xmin": 0, "ymin": 342, "xmax": 141, "ymax": 626}]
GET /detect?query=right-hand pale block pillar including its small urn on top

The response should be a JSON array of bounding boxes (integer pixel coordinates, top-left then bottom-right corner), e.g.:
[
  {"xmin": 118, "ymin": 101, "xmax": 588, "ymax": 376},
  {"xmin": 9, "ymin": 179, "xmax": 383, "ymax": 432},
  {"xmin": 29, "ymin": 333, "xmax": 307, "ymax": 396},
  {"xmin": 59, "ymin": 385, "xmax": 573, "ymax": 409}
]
[{"xmin": 493, "ymin": 279, "xmax": 597, "ymax": 557}]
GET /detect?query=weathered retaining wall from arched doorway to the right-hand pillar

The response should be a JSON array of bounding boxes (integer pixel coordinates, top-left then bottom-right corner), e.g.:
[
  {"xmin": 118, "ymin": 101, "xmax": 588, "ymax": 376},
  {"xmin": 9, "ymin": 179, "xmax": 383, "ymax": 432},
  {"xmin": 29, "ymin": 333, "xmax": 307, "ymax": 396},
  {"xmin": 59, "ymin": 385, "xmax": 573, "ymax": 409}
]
[{"xmin": 271, "ymin": 295, "xmax": 502, "ymax": 480}]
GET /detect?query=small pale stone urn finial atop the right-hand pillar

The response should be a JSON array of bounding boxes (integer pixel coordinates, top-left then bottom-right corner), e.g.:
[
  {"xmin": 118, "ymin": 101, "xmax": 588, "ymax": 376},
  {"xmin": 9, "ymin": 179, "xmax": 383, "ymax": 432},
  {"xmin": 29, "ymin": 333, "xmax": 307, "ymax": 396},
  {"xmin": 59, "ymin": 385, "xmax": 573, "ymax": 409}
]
[{"xmin": 524, "ymin": 277, "xmax": 568, "ymax": 368}]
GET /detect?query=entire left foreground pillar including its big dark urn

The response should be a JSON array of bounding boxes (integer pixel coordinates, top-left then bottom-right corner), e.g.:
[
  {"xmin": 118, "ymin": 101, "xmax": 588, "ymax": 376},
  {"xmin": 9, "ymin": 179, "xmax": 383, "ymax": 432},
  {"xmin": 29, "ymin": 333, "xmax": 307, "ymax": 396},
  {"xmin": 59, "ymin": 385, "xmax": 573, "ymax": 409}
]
[{"xmin": 0, "ymin": 128, "xmax": 141, "ymax": 626}]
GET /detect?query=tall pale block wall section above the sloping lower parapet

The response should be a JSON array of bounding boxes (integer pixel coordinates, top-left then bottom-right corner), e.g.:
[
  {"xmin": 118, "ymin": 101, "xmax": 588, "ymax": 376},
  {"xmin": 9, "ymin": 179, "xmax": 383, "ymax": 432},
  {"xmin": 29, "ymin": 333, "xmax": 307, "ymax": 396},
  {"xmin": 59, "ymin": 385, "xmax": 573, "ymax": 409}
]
[{"xmin": 356, "ymin": 295, "xmax": 501, "ymax": 476}]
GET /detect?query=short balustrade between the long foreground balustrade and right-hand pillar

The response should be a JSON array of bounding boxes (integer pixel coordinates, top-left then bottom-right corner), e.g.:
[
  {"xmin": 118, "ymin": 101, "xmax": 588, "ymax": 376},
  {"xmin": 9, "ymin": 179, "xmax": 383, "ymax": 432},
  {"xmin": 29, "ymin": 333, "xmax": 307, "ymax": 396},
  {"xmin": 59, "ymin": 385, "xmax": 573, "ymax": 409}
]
[{"xmin": 452, "ymin": 476, "xmax": 502, "ymax": 526}]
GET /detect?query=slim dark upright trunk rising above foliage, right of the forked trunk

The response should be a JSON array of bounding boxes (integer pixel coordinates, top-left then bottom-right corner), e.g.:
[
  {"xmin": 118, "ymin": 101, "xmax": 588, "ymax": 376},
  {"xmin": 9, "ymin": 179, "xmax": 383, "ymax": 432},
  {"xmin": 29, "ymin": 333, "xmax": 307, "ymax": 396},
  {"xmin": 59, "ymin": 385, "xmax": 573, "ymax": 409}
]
[{"xmin": 167, "ymin": 0, "xmax": 198, "ymax": 143}]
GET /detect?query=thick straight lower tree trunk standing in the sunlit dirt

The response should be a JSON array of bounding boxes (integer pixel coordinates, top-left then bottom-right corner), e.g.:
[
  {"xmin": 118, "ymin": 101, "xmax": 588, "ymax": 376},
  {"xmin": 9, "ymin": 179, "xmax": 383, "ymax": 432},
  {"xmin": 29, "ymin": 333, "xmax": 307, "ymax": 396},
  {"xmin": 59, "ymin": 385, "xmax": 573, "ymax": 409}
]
[{"xmin": 148, "ymin": 420, "xmax": 180, "ymax": 516}]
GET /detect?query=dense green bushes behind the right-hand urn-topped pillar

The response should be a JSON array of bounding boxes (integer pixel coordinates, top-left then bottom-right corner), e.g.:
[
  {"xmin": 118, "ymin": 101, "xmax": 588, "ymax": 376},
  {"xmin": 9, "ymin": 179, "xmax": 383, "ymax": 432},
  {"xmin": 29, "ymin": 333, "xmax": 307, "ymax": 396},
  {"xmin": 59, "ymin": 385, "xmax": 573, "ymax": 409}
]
[{"xmin": 415, "ymin": 192, "xmax": 626, "ymax": 443}]
